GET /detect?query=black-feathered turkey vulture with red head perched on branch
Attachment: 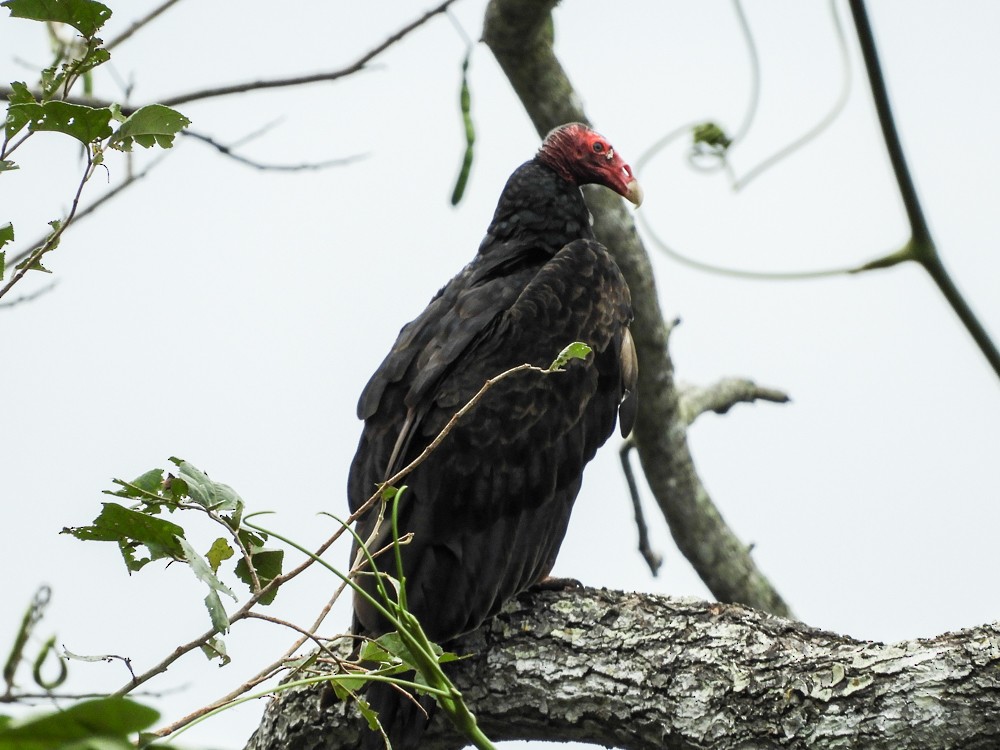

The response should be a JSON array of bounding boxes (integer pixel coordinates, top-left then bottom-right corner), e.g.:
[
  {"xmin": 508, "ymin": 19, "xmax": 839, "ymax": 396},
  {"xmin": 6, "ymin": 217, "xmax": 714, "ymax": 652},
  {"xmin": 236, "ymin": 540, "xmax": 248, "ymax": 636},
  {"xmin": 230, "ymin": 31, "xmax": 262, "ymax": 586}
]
[{"xmin": 348, "ymin": 123, "xmax": 642, "ymax": 749}]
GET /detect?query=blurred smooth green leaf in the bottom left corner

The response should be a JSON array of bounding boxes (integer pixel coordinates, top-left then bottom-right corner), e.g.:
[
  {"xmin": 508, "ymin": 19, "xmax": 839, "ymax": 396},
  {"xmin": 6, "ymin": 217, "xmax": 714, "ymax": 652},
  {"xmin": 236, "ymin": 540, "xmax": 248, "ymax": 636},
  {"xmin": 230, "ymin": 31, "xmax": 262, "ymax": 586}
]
[{"xmin": 0, "ymin": 698, "xmax": 160, "ymax": 750}]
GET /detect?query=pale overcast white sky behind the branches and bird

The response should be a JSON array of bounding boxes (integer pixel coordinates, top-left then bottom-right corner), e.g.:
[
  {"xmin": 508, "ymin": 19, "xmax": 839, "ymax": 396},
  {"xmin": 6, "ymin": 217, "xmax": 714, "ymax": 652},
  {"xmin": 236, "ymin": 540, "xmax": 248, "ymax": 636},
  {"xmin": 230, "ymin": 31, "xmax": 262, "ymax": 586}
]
[{"xmin": 0, "ymin": 0, "xmax": 1000, "ymax": 750}]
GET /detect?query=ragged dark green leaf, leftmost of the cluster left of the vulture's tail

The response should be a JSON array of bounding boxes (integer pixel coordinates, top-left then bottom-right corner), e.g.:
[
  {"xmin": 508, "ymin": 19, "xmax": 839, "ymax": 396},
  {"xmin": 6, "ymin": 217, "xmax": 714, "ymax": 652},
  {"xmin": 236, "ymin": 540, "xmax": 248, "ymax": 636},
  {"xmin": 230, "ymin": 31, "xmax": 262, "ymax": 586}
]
[{"xmin": 60, "ymin": 503, "xmax": 187, "ymax": 571}]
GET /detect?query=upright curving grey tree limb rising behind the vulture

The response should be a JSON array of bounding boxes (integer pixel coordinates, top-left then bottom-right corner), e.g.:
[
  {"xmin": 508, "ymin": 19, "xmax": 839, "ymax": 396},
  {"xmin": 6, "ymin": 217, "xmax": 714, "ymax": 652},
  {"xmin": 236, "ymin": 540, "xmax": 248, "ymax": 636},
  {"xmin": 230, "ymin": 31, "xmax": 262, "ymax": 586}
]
[{"xmin": 483, "ymin": 0, "xmax": 790, "ymax": 615}]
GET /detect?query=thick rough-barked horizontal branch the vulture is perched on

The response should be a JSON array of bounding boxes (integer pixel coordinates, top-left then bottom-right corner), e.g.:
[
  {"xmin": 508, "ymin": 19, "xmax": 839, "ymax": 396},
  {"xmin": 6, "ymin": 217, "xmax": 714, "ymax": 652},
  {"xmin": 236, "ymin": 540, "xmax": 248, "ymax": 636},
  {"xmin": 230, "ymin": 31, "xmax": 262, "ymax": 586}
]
[{"xmin": 247, "ymin": 589, "xmax": 1000, "ymax": 750}]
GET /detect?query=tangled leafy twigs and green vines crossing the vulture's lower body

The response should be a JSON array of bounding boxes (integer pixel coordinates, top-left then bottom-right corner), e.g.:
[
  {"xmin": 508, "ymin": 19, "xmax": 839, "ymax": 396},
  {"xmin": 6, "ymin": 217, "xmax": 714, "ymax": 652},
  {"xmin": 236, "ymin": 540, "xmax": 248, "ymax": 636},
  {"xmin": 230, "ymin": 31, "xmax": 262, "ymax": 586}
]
[{"xmin": 0, "ymin": 342, "xmax": 591, "ymax": 750}]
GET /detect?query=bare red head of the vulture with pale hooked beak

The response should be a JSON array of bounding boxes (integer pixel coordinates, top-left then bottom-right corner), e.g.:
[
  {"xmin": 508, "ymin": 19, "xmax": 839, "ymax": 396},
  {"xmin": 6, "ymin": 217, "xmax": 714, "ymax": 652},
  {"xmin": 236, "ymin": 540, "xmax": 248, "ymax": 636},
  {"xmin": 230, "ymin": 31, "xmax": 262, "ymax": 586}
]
[{"xmin": 538, "ymin": 122, "xmax": 642, "ymax": 206}]
